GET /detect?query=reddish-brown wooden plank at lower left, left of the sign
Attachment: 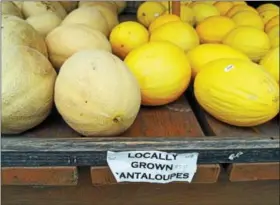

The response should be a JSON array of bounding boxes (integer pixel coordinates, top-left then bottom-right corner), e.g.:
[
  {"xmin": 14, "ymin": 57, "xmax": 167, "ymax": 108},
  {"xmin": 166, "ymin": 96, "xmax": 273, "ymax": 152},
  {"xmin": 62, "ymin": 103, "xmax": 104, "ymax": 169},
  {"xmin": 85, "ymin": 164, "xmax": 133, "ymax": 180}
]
[{"xmin": 1, "ymin": 167, "xmax": 78, "ymax": 186}]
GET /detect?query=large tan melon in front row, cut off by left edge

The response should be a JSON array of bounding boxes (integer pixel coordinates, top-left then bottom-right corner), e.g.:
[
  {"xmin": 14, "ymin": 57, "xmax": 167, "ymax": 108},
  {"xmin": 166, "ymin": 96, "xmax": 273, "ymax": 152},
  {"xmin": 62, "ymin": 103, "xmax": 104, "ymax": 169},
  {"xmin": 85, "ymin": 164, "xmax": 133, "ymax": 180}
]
[{"xmin": 1, "ymin": 46, "xmax": 56, "ymax": 134}]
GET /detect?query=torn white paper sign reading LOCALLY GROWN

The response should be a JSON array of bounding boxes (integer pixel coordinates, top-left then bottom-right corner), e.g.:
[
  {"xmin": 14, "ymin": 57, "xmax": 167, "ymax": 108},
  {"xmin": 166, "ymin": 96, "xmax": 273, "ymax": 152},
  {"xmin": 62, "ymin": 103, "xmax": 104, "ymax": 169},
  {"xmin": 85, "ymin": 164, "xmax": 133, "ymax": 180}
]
[{"xmin": 107, "ymin": 151, "xmax": 198, "ymax": 184}]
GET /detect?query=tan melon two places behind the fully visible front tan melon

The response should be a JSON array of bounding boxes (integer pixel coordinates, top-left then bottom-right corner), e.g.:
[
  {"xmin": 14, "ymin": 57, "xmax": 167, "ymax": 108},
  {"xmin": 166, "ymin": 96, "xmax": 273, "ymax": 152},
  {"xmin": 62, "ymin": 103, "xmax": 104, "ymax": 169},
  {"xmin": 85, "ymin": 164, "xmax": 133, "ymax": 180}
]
[{"xmin": 61, "ymin": 7, "xmax": 110, "ymax": 36}]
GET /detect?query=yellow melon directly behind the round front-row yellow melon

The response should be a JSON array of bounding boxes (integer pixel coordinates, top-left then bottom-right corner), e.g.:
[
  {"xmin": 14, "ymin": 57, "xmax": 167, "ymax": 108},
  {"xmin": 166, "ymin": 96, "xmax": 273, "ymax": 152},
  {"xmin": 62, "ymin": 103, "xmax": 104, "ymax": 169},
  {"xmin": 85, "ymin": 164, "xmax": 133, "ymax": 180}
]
[{"xmin": 150, "ymin": 21, "xmax": 199, "ymax": 52}]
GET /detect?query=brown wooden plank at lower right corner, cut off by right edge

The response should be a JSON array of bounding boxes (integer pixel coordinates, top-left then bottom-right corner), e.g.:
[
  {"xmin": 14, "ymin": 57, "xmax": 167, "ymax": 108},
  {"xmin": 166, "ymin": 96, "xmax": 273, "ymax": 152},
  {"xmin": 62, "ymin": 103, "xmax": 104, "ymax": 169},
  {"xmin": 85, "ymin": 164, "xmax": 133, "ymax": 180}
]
[{"xmin": 228, "ymin": 162, "xmax": 280, "ymax": 182}]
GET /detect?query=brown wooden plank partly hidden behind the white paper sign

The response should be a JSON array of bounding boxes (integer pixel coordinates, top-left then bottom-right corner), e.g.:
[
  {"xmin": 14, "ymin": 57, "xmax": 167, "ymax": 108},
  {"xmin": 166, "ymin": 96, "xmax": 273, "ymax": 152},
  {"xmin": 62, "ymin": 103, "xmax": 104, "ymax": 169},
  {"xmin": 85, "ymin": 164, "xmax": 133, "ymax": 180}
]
[{"xmin": 91, "ymin": 164, "xmax": 220, "ymax": 186}]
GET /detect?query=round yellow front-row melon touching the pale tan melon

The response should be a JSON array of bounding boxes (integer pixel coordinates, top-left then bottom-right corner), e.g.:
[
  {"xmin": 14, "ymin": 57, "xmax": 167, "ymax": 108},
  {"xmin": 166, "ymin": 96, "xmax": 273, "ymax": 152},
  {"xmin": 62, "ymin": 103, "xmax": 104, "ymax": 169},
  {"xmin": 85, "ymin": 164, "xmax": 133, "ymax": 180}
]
[{"xmin": 124, "ymin": 41, "xmax": 191, "ymax": 106}]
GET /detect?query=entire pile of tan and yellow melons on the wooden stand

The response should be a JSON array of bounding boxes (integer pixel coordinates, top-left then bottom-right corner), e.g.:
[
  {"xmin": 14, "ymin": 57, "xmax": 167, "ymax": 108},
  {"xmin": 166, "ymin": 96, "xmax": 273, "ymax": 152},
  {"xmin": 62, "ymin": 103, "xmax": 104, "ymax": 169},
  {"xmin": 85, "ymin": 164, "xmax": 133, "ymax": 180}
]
[{"xmin": 1, "ymin": 1, "xmax": 279, "ymax": 136}]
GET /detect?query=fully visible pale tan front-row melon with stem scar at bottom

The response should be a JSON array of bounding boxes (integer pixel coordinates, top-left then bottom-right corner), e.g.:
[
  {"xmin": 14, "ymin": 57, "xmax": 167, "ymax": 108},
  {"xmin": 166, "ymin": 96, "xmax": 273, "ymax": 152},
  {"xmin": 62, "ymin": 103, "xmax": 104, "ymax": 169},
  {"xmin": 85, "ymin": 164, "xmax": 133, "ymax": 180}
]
[{"xmin": 55, "ymin": 49, "xmax": 141, "ymax": 136}]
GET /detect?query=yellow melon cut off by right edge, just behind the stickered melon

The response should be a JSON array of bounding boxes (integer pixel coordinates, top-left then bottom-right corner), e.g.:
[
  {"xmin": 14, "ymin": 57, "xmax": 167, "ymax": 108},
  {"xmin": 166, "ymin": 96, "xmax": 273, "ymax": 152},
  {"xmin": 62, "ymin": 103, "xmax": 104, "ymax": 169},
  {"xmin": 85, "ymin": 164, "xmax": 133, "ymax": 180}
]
[{"xmin": 260, "ymin": 46, "xmax": 280, "ymax": 84}]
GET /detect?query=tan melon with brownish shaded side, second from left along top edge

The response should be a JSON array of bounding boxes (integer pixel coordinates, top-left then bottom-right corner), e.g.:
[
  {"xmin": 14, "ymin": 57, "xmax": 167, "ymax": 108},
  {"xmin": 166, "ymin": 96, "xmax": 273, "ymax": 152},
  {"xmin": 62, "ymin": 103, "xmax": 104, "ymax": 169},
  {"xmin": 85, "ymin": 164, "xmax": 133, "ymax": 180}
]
[{"xmin": 22, "ymin": 1, "xmax": 67, "ymax": 19}]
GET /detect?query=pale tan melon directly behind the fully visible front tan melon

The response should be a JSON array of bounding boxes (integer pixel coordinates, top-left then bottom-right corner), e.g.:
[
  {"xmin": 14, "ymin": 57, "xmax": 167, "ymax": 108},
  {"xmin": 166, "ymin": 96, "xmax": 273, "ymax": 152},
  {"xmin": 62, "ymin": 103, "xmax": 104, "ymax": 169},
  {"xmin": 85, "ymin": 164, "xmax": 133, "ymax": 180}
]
[{"xmin": 45, "ymin": 24, "xmax": 112, "ymax": 69}]
